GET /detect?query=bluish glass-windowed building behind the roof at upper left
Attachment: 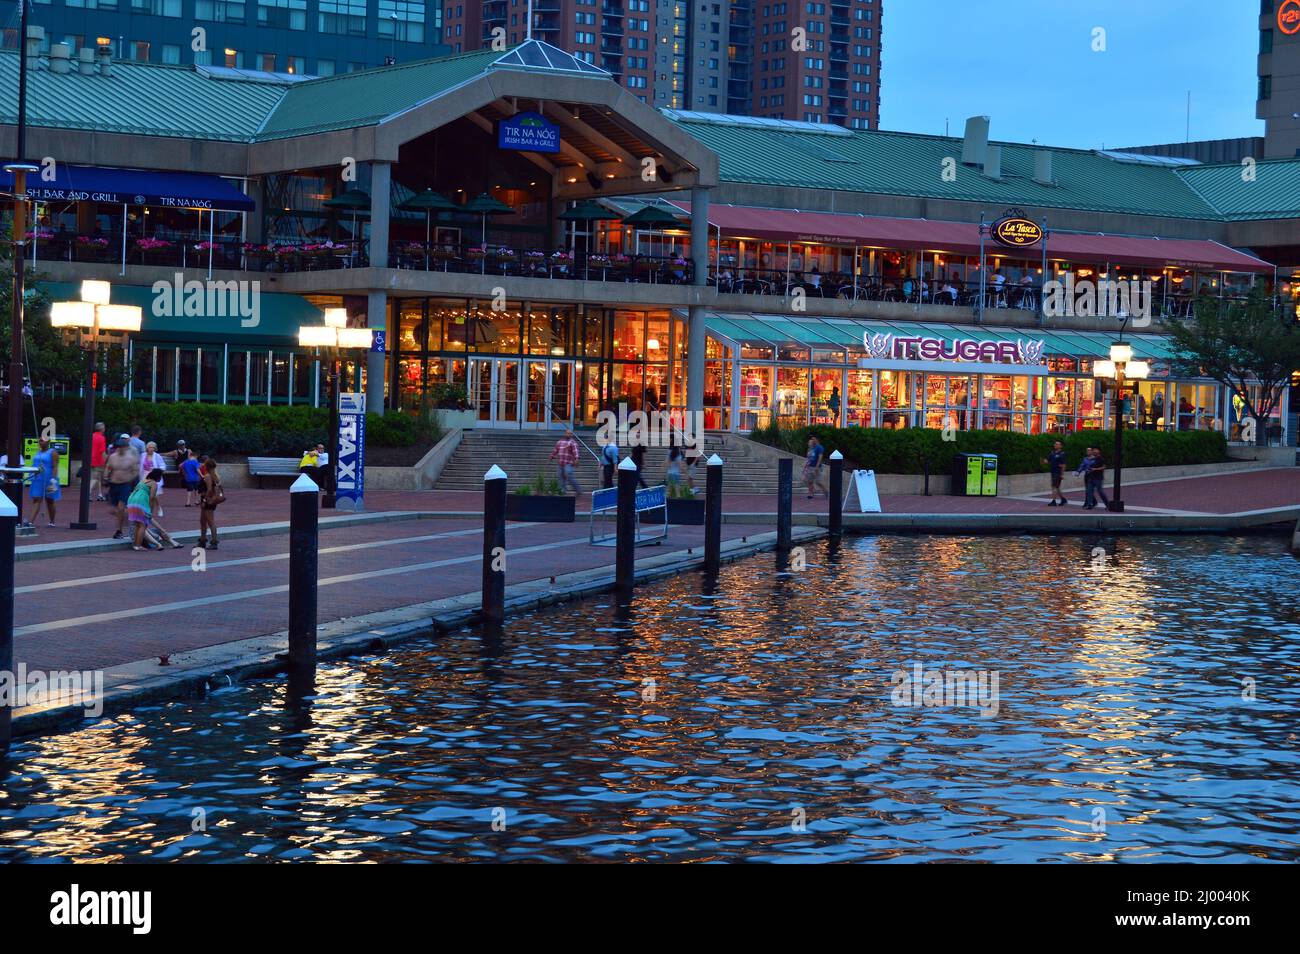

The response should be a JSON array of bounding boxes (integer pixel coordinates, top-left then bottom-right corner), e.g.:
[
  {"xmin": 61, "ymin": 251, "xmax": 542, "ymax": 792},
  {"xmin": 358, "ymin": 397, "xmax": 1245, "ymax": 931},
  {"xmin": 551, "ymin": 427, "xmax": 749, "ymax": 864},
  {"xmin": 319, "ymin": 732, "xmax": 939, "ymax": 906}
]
[{"xmin": 4, "ymin": 0, "xmax": 447, "ymax": 75}]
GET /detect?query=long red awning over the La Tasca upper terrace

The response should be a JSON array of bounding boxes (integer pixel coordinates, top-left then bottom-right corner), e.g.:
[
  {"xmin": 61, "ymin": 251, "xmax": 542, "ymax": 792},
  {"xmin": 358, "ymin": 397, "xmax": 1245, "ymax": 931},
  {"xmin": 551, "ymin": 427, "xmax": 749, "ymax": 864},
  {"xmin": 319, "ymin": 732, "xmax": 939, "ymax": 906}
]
[{"xmin": 673, "ymin": 201, "xmax": 1273, "ymax": 272}]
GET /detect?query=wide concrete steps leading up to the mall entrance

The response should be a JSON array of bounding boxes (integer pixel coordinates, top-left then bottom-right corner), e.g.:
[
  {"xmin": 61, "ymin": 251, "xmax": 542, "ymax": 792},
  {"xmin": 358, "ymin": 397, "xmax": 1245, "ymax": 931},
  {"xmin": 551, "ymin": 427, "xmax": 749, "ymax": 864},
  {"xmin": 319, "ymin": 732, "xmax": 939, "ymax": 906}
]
[{"xmin": 434, "ymin": 429, "xmax": 801, "ymax": 494}]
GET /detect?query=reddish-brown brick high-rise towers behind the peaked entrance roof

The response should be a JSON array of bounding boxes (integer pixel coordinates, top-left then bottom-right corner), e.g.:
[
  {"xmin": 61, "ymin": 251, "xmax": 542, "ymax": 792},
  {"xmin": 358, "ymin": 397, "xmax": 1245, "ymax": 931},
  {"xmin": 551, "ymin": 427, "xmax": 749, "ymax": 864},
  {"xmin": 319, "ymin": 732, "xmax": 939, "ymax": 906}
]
[{"xmin": 442, "ymin": 0, "xmax": 883, "ymax": 129}]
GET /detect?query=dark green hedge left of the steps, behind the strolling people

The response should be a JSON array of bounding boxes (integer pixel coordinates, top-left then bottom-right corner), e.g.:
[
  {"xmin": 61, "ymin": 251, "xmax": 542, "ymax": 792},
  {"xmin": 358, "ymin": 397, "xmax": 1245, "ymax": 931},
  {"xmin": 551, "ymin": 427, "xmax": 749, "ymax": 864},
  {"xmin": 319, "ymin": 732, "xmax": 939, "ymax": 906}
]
[{"xmin": 3, "ymin": 398, "xmax": 439, "ymax": 458}]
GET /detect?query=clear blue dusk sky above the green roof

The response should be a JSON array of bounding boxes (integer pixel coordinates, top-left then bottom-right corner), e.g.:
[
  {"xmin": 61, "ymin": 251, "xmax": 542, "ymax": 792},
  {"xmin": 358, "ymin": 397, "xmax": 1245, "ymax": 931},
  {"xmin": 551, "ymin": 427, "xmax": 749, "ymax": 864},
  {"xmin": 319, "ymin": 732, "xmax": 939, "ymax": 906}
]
[{"xmin": 880, "ymin": 0, "xmax": 1264, "ymax": 148}]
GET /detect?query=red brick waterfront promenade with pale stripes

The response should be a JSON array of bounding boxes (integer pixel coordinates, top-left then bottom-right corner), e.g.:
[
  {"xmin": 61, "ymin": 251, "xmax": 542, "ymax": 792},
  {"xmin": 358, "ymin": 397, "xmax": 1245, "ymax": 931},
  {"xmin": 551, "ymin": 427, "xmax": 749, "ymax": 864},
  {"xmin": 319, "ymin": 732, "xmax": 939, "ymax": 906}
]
[{"xmin": 16, "ymin": 468, "xmax": 1300, "ymax": 669}]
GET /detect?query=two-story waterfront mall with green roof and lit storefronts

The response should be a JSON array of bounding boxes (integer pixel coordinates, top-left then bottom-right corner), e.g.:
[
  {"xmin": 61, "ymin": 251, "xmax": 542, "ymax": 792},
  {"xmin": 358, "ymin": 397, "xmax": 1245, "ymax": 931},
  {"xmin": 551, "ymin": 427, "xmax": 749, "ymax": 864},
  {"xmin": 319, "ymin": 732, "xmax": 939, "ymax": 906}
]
[{"xmin": 0, "ymin": 40, "xmax": 1300, "ymax": 442}]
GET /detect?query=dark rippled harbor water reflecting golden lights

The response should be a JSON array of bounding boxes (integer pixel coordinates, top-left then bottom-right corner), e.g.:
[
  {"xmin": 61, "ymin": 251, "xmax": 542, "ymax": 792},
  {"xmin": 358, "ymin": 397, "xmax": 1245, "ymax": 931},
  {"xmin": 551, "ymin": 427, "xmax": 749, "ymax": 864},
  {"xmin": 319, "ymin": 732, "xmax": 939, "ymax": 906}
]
[{"xmin": 0, "ymin": 537, "xmax": 1300, "ymax": 862}]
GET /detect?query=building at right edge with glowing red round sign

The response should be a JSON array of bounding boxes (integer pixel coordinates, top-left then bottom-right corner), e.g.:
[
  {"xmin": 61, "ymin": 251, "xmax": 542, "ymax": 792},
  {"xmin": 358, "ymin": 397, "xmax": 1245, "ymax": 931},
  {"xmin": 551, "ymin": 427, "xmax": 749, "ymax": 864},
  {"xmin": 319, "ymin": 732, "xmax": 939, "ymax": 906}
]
[{"xmin": 1255, "ymin": 0, "xmax": 1300, "ymax": 159}]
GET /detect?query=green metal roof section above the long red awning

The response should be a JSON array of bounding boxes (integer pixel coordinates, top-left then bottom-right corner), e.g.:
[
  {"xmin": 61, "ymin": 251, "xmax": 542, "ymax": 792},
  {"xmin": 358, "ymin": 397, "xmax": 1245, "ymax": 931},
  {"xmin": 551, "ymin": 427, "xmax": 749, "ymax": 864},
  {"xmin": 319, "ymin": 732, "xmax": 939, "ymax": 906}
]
[{"xmin": 666, "ymin": 110, "xmax": 1300, "ymax": 220}]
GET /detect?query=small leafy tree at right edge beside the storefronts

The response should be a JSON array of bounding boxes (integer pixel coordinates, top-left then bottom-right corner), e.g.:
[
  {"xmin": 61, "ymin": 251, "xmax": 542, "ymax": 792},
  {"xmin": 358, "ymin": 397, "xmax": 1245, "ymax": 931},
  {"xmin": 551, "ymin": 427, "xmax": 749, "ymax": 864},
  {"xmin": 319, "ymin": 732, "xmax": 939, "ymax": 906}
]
[{"xmin": 1165, "ymin": 282, "xmax": 1300, "ymax": 447}]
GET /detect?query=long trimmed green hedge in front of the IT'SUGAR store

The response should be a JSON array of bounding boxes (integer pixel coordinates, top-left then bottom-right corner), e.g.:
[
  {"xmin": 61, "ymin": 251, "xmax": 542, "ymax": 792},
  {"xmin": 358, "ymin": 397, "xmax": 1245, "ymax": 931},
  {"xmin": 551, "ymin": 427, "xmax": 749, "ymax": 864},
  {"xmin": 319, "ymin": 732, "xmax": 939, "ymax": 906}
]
[{"xmin": 750, "ymin": 425, "xmax": 1229, "ymax": 474}]
